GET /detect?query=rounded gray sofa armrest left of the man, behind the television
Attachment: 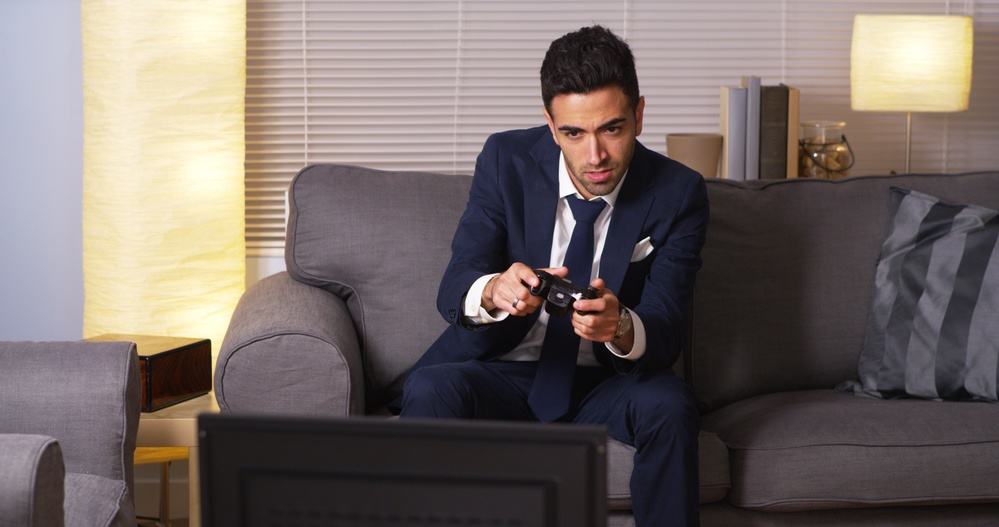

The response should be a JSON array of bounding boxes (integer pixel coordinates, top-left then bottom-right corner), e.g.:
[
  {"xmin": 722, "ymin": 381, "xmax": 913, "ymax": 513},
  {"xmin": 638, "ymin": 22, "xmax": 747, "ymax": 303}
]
[{"xmin": 215, "ymin": 272, "xmax": 364, "ymax": 416}]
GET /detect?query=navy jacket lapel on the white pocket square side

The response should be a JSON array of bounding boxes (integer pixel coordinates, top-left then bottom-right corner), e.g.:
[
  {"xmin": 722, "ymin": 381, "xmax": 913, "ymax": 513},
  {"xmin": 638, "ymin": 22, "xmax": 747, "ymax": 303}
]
[{"xmin": 600, "ymin": 144, "xmax": 653, "ymax": 294}]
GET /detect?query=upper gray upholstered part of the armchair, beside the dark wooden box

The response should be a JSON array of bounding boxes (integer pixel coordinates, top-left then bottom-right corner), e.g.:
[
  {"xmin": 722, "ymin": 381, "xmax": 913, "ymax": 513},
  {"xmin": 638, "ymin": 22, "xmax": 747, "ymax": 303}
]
[{"xmin": 0, "ymin": 341, "xmax": 139, "ymax": 495}]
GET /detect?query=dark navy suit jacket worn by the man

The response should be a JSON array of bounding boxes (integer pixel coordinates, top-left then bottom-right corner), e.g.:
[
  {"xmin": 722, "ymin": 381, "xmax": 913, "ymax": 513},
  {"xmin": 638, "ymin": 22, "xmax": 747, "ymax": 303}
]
[{"xmin": 414, "ymin": 126, "xmax": 708, "ymax": 373}]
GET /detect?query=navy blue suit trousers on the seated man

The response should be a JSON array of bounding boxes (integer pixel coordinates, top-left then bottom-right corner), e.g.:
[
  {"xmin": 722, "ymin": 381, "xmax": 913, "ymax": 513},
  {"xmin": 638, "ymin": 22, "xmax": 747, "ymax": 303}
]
[{"xmin": 401, "ymin": 361, "xmax": 700, "ymax": 527}]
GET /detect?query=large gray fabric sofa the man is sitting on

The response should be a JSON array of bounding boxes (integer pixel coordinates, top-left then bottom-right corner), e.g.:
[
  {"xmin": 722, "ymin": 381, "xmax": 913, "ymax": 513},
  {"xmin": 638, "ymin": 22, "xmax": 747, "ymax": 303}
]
[{"xmin": 215, "ymin": 165, "xmax": 999, "ymax": 525}]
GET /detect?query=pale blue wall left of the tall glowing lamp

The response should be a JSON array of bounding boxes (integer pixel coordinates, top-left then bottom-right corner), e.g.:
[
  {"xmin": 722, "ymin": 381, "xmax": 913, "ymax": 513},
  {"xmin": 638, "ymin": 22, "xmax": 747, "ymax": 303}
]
[{"xmin": 0, "ymin": 0, "xmax": 83, "ymax": 340}]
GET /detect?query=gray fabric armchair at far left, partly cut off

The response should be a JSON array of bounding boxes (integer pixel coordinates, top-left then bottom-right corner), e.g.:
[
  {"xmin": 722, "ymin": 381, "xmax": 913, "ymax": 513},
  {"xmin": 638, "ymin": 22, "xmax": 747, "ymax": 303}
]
[{"xmin": 0, "ymin": 342, "xmax": 139, "ymax": 527}]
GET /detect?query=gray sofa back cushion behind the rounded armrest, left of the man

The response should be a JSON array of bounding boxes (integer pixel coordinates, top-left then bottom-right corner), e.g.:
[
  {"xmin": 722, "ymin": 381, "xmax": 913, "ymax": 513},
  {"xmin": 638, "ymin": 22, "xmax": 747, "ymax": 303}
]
[{"xmin": 285, "ymin": 165, "xmax": 472, "ymax": 396}]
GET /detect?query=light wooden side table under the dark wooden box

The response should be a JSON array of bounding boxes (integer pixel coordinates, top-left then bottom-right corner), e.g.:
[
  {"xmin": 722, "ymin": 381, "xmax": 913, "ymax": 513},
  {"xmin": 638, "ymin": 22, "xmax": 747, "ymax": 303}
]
[{"xmin": 135, "ymin": 392, "xmax": 219, "ymax": 527}]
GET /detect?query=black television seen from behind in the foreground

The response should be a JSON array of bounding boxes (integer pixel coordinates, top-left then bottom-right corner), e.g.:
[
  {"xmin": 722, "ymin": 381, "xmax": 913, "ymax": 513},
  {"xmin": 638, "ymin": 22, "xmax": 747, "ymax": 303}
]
[{"xmin": 198, "ymin": 414, "xmax": 607, "ymax": 527}]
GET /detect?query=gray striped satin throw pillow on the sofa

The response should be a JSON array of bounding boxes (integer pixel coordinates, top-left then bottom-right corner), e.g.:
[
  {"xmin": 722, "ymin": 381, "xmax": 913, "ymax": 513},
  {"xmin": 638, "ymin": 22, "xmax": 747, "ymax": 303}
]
[{"xmin": 859, "ymin": 187, "xmax": 999, "ymax": 401}]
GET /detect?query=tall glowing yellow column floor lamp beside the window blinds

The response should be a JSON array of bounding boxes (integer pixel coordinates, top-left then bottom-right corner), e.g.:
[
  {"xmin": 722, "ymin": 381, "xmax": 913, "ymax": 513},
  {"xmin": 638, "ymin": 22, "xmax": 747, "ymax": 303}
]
[{"xmin": 81, "ymin": 0, "xmax": 246, "ymax": 366}]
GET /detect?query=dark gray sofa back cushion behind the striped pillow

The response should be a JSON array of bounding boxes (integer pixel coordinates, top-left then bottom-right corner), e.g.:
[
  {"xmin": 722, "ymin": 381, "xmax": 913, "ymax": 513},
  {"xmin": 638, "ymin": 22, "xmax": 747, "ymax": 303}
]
[{"xmin": 692, "ymin": 172, "xmax": 999, "ymax": 408}]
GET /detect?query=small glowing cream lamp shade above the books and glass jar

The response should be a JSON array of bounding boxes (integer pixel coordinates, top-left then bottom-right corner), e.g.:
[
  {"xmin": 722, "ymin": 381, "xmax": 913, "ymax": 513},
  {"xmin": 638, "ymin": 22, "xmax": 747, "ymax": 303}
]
[{"xmin": 850, "ymin": 15, "xmax": 974, "ymax": 112}]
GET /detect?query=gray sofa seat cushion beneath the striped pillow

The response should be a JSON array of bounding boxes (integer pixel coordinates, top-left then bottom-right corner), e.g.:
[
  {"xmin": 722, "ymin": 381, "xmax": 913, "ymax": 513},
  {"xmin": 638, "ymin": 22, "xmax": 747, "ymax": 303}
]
[{"xmin": 703, "ymin": 390, "xmax": 999, "ymax": 511}]
